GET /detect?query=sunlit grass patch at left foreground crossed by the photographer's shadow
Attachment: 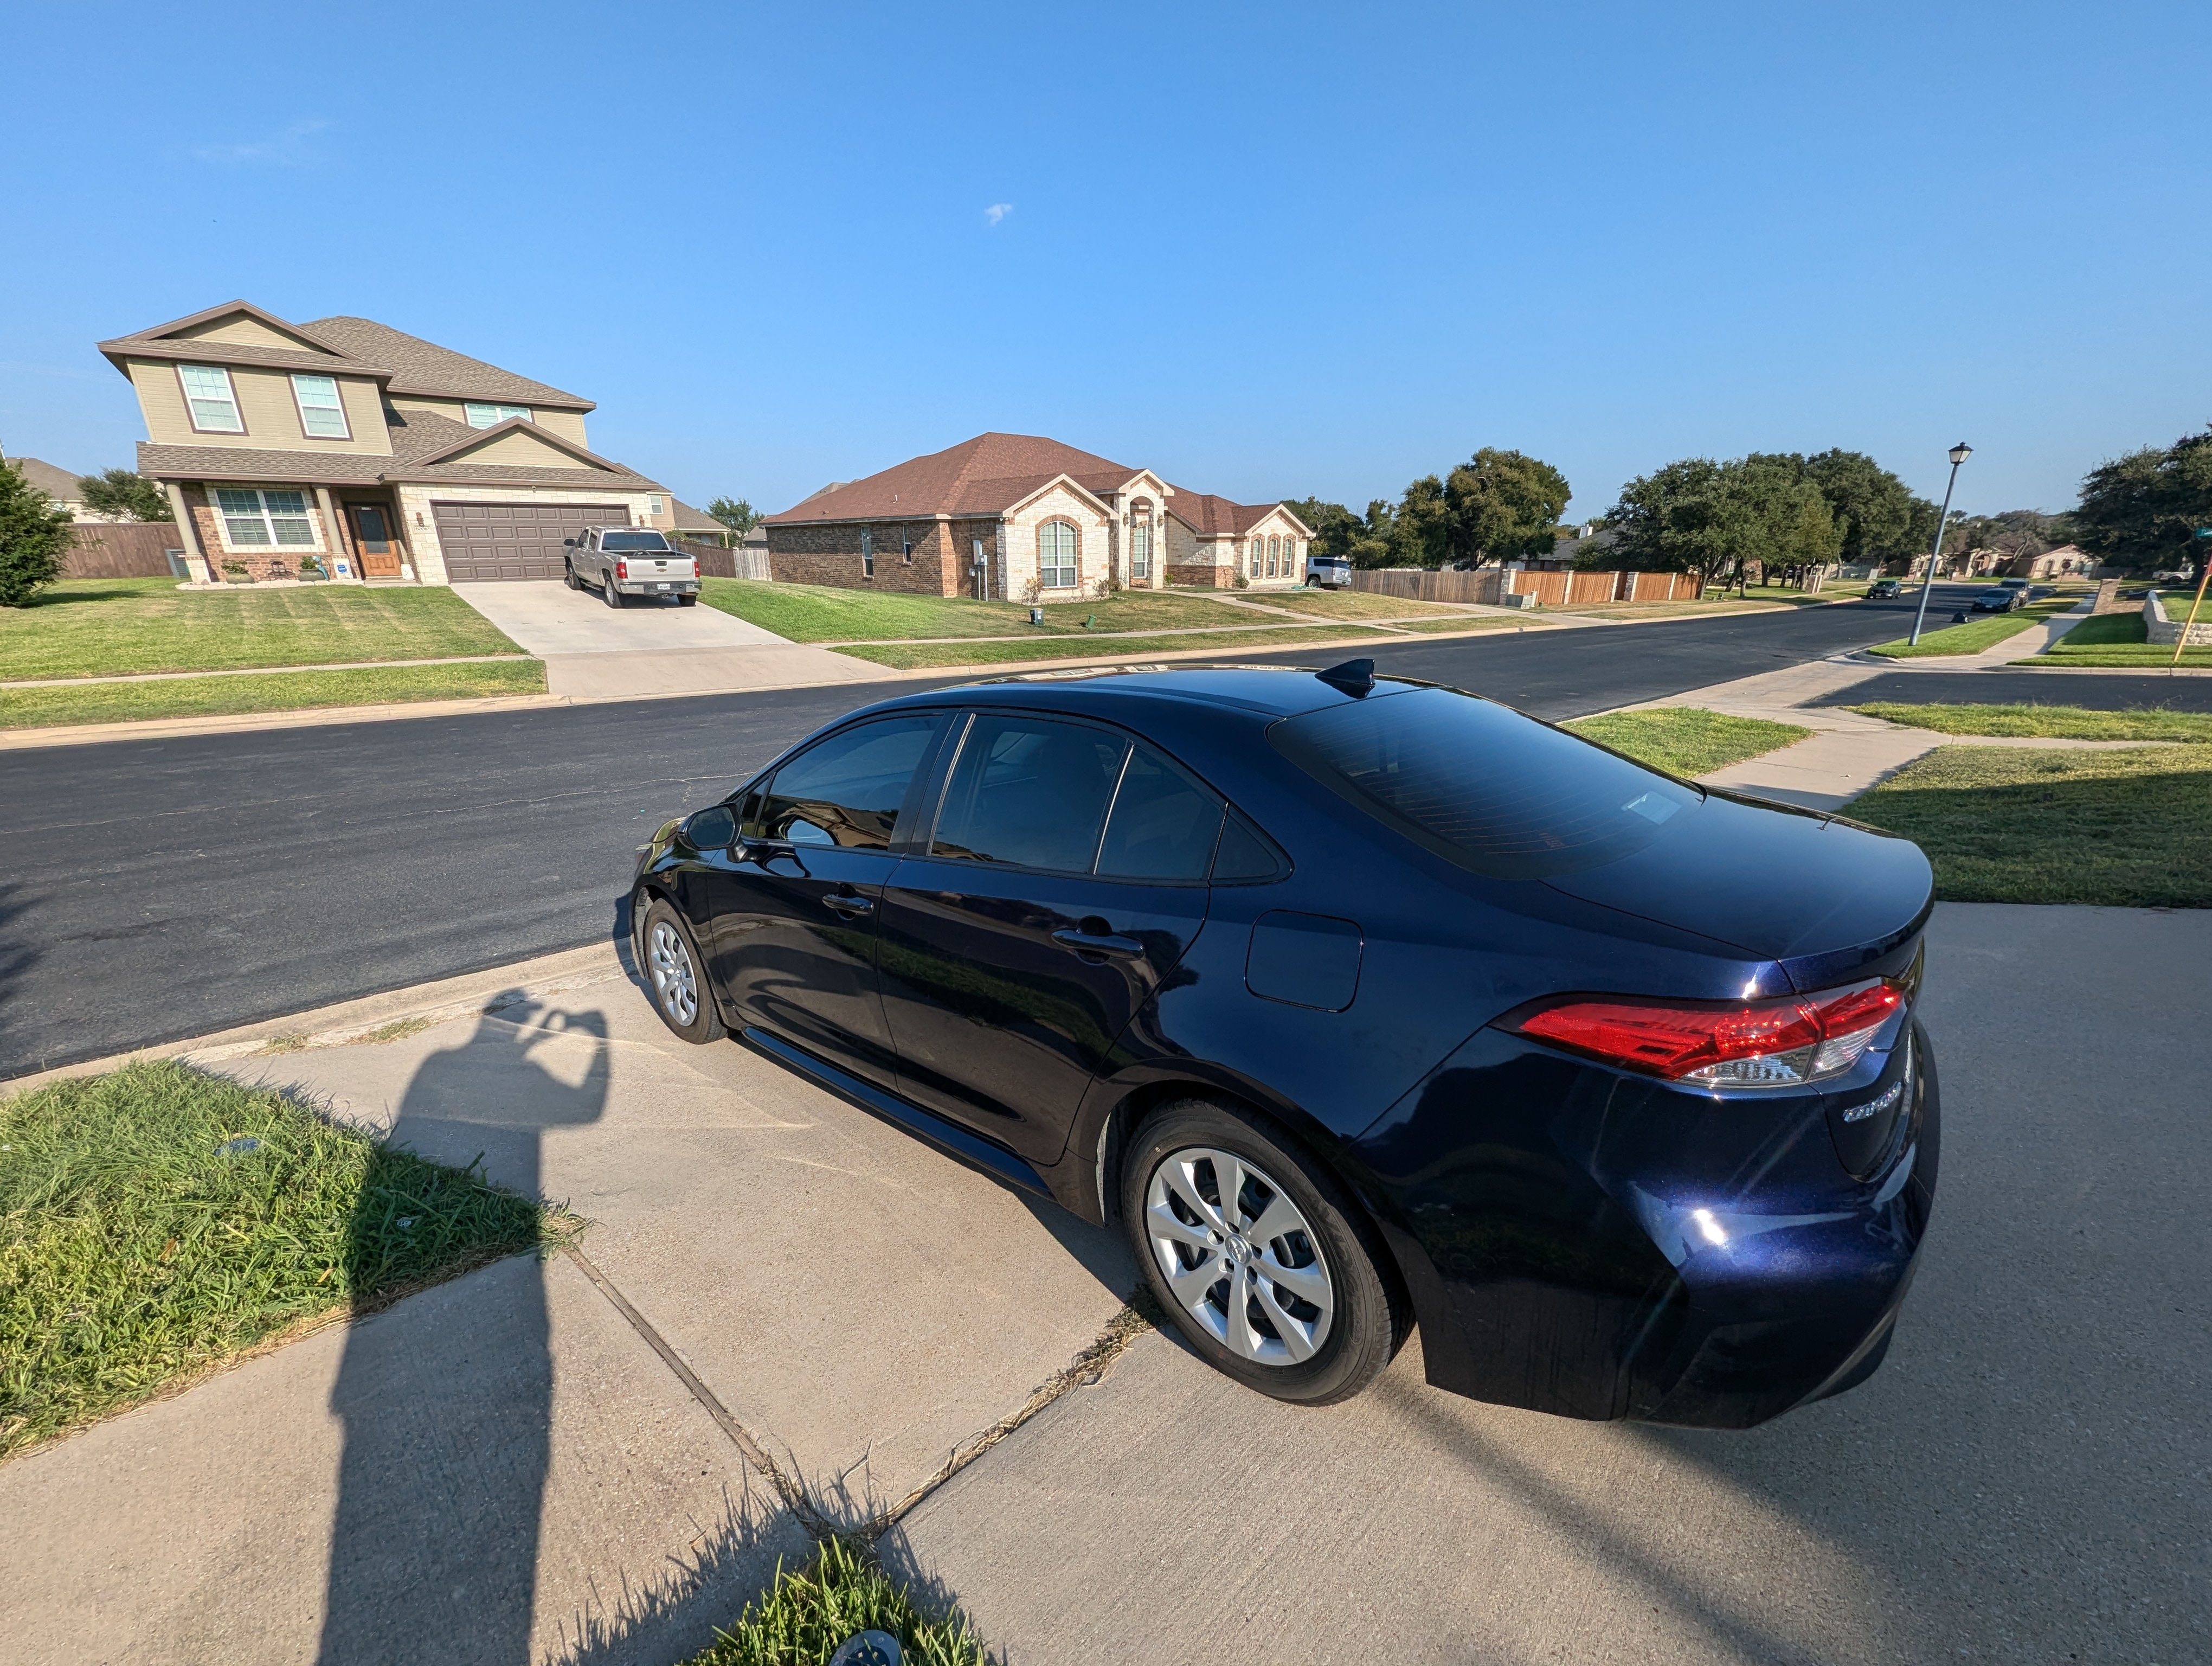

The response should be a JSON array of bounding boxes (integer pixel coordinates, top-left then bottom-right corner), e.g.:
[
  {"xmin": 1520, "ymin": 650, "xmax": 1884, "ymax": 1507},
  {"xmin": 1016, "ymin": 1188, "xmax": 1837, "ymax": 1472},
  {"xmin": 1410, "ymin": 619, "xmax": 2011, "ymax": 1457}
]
[{"xmin": 0, "ymin": 1060, "xmax": 580, "ymax": 1456}]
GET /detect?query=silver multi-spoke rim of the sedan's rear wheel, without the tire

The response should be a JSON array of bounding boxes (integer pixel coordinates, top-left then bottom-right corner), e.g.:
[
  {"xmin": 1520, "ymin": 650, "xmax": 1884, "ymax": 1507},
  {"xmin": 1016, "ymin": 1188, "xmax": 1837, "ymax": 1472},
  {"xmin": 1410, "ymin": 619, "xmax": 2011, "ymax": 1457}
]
[{"xmin": 1143, "ymin": 1146, "xmax": 1336, "ymax": 1365}]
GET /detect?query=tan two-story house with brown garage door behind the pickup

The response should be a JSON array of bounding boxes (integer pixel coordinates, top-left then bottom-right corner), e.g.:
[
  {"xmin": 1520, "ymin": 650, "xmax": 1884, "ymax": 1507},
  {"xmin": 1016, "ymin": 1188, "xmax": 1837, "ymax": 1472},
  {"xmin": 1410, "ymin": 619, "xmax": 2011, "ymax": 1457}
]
[{"xmin": 100, "ymin": 301, "xmax": 679, "ymax": 584}]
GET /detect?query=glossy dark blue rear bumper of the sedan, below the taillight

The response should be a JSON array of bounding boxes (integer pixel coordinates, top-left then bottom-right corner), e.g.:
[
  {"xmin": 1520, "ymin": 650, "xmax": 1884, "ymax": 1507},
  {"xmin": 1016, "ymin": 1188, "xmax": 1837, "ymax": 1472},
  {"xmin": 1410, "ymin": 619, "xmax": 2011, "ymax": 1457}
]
[{"xmin": 1352, "ymin": 1029, "xmax": 1940, "ymax": 1429}]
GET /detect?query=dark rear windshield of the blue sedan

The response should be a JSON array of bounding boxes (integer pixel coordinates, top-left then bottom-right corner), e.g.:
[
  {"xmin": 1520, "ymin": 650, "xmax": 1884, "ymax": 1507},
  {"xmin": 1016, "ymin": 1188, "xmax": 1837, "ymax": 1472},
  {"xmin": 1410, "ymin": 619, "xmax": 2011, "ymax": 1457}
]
[{"xmin": 1268, "ymin": 688, "xmax": 1703, "ymax": 879}]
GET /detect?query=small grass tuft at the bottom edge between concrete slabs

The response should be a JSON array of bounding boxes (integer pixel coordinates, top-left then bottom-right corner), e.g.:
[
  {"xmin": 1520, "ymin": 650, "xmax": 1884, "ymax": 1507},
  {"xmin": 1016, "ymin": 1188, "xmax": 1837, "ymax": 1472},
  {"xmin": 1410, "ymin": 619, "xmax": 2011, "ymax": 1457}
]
[{"xmin": 684, "ymin": 1540, "xmax": 989, "ymax": 1666}]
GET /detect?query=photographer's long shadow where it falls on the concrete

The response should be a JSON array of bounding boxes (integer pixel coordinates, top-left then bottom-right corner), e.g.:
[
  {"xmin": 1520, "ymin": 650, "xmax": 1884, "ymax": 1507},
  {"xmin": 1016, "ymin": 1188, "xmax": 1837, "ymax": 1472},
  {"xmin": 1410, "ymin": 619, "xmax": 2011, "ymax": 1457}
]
[{"xmin": 316, "ymin": 991, "xmax": 608, "ymax": 1666}]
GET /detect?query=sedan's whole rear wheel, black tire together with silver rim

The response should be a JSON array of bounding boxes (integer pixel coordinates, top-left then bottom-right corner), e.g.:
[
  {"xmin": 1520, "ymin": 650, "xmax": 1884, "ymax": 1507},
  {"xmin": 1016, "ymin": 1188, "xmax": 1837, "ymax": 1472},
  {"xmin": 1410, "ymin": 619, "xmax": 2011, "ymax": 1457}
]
[{"xmin": 1122, "ymin": 1100, "xmax": 1409, "ymax": 1405}]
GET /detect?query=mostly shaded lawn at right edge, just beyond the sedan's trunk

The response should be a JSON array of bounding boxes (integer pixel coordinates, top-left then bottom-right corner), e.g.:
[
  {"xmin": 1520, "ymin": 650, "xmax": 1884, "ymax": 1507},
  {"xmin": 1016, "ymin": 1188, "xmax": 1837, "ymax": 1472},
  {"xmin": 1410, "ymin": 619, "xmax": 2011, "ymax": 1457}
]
[{"xmin": 1847, "ymin": 746, "xmax": 2212, "ymax": 907}]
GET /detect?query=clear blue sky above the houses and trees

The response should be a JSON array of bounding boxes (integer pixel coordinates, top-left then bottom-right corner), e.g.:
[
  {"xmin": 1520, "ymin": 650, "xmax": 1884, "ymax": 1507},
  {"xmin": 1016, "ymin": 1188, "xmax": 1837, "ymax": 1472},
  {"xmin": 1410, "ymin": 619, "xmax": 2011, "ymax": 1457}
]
[{"xmin": 0, "ymin": 0, "xmax": 2212, "ymax": 513}]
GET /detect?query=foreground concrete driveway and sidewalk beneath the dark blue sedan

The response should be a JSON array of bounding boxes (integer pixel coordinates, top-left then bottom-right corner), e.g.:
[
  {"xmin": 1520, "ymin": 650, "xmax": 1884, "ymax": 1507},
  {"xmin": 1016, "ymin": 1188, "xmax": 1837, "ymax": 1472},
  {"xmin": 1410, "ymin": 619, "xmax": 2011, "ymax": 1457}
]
[{"xmin": 0, "ymin": 905, "xmax": 2212, "ymax": 1666}]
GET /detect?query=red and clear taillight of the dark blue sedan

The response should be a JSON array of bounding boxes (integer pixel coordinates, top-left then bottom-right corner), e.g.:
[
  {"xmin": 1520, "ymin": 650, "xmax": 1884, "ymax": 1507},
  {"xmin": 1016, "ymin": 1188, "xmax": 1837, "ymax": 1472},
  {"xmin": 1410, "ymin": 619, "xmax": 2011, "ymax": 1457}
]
[{"xmin": 1504, "ymin": 978, "xmax": 1905, "ymax": 1088}]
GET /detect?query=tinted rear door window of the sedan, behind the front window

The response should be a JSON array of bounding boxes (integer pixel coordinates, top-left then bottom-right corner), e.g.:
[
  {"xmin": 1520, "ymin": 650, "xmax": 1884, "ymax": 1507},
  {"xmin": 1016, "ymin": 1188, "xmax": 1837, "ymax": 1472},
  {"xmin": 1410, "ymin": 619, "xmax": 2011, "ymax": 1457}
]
[{"xmin": 929, "ymin": 717, "xmax": 1128, "ymax": 874}]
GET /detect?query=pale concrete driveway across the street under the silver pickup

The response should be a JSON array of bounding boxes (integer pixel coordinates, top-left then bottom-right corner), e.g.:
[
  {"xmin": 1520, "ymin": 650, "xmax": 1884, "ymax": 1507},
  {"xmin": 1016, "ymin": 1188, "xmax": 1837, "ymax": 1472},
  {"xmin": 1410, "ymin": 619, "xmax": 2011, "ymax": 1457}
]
[{"xmin": 453, "ymin": 580, "xmax": 883, "ymax": 697}]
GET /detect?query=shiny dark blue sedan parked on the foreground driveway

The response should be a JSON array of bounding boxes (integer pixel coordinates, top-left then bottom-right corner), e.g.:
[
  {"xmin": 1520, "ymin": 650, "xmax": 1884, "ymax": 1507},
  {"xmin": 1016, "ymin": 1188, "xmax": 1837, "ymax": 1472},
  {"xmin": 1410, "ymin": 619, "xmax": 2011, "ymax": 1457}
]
[{"xmin": 633, "ymin": 662, "xmax": 1938, "ymax": 1427}]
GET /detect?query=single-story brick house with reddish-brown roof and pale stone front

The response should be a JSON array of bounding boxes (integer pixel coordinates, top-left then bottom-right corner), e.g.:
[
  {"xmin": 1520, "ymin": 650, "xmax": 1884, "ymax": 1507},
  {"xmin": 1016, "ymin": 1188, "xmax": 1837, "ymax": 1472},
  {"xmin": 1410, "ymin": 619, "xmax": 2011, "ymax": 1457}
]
[{"xmin": 761, "ymin": 434, "xmax": 1311, "ymax": 602}]
